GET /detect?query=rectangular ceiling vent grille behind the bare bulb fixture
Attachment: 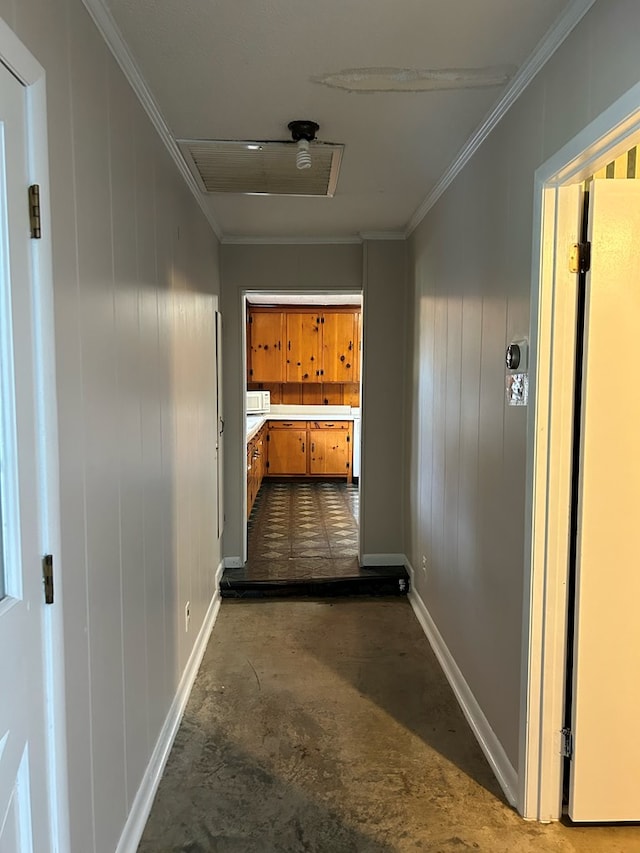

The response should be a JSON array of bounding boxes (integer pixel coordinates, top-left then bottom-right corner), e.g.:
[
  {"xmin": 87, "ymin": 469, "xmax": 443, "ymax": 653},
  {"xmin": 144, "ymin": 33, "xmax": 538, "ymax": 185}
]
[{"xmin": 178, "ymin": 139, "xmax": 344, "ymax": 197}]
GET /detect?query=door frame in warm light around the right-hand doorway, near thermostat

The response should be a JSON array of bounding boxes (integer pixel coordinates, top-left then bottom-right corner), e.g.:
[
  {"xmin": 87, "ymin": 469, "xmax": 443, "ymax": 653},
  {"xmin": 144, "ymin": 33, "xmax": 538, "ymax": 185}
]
[{"xmin": 518, "ymin": 83, "xmax": 640, "ymax": 821}]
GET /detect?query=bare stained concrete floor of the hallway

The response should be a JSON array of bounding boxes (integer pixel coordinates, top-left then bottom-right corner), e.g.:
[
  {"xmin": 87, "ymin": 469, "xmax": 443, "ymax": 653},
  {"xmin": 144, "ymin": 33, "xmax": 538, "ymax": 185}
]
[{"xmin": 139, "ymin": 598, "xmax": 640, "ymax": 853}]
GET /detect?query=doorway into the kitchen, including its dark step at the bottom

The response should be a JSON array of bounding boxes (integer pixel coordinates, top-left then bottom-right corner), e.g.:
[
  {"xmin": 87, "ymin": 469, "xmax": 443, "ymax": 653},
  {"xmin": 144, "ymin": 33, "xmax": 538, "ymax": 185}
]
[{"xmin": 221, "ymin": 291, "xmax": 405, "ymax": 597}]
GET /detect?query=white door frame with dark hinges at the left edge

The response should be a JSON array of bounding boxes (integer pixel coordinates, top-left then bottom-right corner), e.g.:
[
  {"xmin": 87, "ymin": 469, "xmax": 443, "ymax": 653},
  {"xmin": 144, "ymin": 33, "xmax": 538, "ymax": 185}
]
[{"xmin": 0, "ymin": 18, "xmax": 70, "ymax": 853}]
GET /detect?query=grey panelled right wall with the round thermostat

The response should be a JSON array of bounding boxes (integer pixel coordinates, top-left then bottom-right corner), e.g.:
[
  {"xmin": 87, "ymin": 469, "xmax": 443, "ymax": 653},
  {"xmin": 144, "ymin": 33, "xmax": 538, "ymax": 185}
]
[{"xmin": 406, "ymin": 0, "xmax": 640, "ymax": 769}]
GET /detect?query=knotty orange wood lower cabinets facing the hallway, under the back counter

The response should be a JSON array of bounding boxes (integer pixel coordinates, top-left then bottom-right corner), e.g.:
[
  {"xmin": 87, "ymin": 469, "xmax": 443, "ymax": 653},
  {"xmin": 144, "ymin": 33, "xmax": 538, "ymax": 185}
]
[{"xmin": 266, "ymin": 421, "xmax": 353, "ymax": 482}]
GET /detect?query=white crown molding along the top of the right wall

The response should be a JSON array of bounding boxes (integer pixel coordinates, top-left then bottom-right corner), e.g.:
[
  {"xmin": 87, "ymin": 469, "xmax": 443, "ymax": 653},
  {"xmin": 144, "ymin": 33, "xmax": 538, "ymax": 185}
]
[{"xmin": 405, "ymin": 0, "xmax": 595, "ymax": 237}]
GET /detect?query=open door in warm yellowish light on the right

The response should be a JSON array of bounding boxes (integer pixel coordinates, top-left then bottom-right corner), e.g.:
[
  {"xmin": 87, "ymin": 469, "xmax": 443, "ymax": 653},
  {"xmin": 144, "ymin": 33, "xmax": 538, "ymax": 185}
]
[{"xmin": 569, "ymin": 180, "xmax": 640, "ymax": 821}]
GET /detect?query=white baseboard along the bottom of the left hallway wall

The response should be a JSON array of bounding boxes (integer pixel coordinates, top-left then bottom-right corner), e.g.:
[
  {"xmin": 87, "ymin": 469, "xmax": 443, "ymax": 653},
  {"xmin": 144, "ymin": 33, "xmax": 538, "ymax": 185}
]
[{"xmin": 116, "ymin": 563, "xmax": 223, "ymax": 853}]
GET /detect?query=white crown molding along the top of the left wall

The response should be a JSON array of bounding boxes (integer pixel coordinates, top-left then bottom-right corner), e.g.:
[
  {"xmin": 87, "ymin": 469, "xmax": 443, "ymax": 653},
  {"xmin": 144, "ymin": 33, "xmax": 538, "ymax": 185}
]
[{"xmin": 82, "ymin": 0, "xmax": 223, "ymax": 241}]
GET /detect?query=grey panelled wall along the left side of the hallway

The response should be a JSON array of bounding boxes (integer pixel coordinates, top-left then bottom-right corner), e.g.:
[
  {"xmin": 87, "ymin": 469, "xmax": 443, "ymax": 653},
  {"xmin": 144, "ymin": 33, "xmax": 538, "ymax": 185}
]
[{"xmin": 0, "ymin": 0, "xmax": 220, "ymax": 853}]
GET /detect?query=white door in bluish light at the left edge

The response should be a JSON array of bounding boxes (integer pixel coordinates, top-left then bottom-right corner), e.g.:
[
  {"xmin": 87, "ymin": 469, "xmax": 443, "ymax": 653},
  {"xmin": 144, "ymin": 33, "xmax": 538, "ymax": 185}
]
[{"xmin": 0, "ymin": 64, "xmax": 51, "ymax": 853}]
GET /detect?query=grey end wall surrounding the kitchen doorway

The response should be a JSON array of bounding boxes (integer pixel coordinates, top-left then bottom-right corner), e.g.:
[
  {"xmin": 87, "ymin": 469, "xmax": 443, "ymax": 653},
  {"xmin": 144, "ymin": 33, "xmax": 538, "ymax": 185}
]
[{"xmin": 222, "ymin": 241, "xmax": 406, "ymax": 558}]
